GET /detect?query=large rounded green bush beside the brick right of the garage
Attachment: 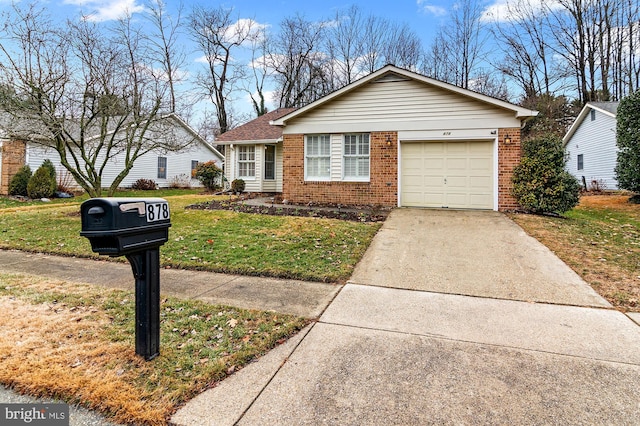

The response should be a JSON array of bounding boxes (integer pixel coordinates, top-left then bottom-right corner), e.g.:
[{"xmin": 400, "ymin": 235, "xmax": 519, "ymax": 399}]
[{"xmin": 512, "ymin": 135, "xmax": 580, "ymax": 214}]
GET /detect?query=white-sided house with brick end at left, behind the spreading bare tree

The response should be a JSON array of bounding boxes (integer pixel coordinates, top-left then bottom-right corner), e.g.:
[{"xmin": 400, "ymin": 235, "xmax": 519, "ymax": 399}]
[{"xmin": 0, "ymin": 114, "xmax": 224, "ymax": 194}]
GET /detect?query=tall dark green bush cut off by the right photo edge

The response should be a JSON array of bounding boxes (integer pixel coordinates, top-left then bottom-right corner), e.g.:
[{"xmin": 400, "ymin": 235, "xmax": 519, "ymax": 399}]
[{"xmin": 615, "ymin": 90, "xmax": 640, "ymax": 196}]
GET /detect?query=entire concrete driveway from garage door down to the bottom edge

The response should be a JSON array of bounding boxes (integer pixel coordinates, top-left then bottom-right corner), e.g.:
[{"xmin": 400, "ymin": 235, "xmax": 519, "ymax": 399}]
[{"xmin": 172, "ymin": 209, "xmax": 640, "ymax": 425}]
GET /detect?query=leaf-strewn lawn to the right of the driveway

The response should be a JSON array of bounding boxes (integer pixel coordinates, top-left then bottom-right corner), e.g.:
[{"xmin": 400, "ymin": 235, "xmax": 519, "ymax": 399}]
[{"xmin": 511, "ymin": 195, "xmax": 640, "ymax": 312}]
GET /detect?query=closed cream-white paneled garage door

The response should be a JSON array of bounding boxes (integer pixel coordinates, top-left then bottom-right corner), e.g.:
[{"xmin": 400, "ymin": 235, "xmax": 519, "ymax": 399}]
[{"xmin": 400, "ymin": 141, "xmax": 493, "ymax": 209}]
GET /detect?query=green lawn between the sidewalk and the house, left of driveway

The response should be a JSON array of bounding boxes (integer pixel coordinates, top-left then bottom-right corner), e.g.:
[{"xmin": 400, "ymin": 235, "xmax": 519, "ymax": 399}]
[{"xmin": 0, "ymin": 192, "xmax": 380, "ymax": 282}]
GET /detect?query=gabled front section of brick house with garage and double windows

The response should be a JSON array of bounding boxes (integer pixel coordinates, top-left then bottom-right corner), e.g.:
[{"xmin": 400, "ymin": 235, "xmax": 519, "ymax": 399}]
[{"xmin": 272, "ymin": 65, "xmax": 537, "ymax": 210}]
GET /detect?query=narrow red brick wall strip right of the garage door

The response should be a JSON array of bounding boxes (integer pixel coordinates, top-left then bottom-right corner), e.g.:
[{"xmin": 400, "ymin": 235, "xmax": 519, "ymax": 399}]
[{"xmin": 498, "ymin": 127, "xmax": 521, "ymax": 211}]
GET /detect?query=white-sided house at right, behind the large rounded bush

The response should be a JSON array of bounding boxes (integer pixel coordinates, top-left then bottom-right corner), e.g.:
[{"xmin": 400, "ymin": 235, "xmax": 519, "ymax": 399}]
[{"xmin": 562, "ymin": 102, "xmax": 618, "ymax": 189}]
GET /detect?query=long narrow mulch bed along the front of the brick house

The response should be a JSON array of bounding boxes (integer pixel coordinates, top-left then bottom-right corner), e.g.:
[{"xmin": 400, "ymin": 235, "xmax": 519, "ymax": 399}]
[{"xmin": 187, "ymin": 200, "xmax": 389, "ymax": 222}]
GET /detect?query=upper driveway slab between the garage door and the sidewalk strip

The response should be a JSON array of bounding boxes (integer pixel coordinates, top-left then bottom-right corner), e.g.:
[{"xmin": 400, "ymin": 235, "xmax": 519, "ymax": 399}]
[{"xmin": 350, "ymin": 209, "xmax": 610, "ymax": 307}]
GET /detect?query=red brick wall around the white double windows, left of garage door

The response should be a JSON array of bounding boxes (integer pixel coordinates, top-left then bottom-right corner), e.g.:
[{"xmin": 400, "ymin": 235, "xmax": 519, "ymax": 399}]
[{"xmin": 282, "ymin": 132, "xmax": 398, "ymax": 206}]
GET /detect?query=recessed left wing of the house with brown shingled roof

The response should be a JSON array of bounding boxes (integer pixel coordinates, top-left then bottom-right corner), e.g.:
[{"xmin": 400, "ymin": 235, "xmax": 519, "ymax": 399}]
[{"xmin": 216, "ymin": 108, "xmax": 295, "ymax": 192}]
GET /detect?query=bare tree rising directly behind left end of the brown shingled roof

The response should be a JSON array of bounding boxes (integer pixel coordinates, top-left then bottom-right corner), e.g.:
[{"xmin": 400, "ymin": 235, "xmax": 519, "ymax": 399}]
[{"xmin": 189, "ymin": 6, "xmax": 255, "ymax": 133}]
